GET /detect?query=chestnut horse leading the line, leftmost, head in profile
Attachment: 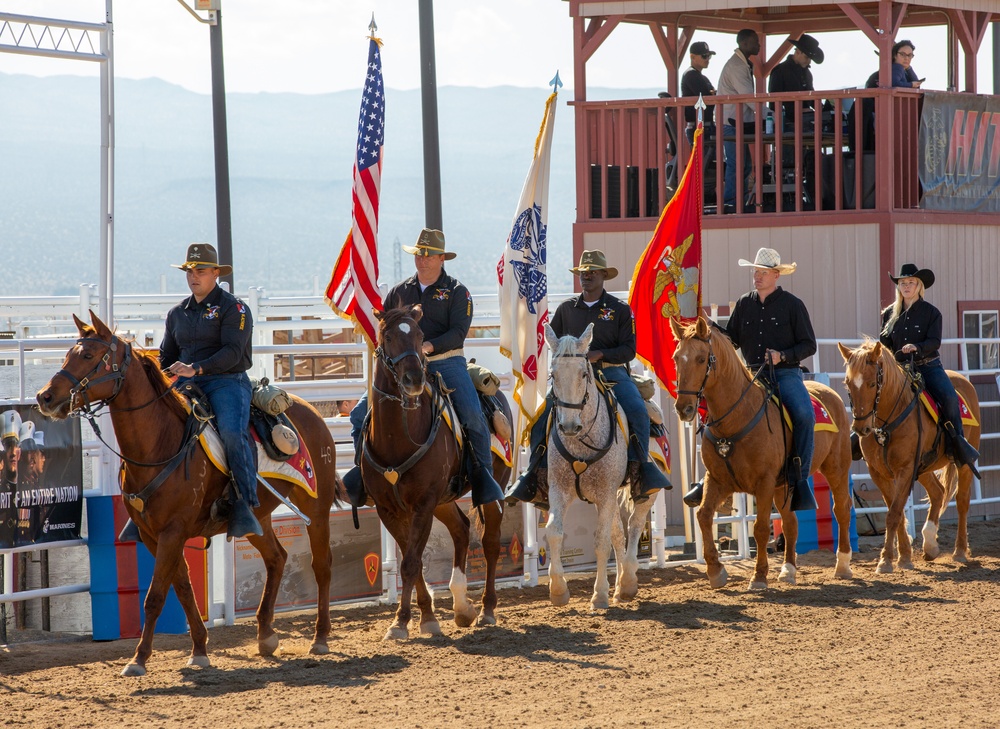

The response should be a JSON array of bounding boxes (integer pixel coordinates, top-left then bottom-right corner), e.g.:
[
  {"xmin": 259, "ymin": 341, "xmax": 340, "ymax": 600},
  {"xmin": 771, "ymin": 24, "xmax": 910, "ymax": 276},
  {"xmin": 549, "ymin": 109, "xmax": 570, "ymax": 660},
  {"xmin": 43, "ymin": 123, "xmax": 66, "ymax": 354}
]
[{"xmin": 36, "ymin": 312, "xmax": 342, "ymax": 676}]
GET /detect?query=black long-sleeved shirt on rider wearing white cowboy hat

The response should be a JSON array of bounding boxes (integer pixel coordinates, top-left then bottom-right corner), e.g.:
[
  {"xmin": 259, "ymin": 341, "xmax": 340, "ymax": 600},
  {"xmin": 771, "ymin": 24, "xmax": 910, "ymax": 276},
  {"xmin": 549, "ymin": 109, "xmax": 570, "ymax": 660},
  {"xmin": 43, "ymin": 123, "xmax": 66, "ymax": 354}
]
[{"xmin": 726, "ymin": 286, "xmax": 816, "ymax": 367}]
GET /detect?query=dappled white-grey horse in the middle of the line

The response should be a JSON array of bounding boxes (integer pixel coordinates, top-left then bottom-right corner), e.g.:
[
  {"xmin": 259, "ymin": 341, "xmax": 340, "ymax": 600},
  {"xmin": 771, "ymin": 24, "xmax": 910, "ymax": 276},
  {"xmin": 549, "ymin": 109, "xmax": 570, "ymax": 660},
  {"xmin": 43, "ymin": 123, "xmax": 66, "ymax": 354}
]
[{"xmin": 545, "ymin": 324, "xmax": 653, "ymax": 610}]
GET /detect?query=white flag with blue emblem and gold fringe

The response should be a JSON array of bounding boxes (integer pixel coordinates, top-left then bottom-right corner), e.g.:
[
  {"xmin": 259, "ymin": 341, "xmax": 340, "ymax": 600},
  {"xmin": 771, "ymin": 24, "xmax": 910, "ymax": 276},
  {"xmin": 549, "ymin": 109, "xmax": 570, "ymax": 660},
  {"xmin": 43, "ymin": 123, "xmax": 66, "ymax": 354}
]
[{"xmin": 497, "ymin": 86, "xmax": 561, "ymax": 435}]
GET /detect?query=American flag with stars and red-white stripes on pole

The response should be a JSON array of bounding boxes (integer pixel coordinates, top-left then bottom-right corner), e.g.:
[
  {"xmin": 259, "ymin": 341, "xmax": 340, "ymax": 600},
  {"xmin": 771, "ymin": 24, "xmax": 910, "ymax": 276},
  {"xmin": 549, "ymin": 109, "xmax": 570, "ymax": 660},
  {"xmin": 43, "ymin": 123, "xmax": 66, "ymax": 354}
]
[{"xmin": 326, "ymin": 36, "xmax": 385, "ymax": 348}]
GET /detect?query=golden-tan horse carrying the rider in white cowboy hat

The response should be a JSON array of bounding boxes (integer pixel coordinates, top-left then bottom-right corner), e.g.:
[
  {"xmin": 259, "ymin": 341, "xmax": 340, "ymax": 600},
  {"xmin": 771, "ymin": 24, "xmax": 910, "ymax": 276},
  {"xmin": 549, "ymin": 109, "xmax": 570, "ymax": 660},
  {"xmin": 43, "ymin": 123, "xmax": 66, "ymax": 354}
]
[{"xmin": 670, "ymin": 318, "xmax": 852, "ymax": 590}]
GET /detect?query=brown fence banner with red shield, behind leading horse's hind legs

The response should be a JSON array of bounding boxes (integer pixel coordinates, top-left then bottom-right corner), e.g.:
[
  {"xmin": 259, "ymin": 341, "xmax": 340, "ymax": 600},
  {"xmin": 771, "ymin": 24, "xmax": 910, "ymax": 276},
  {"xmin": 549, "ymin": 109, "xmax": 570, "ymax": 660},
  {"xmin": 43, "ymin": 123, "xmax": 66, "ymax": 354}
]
[{"xmin": 234, "ymin": 509, "xmax": 382, "ymax": 617}]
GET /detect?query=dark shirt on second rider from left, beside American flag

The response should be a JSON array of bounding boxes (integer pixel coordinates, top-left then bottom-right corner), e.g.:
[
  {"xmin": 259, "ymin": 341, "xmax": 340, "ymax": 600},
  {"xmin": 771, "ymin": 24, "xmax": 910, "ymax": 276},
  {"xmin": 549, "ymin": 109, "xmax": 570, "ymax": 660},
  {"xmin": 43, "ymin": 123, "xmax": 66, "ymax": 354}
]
[{"xmin": 385, "ymin": 268, "xmax": 472, "ymax": 356}]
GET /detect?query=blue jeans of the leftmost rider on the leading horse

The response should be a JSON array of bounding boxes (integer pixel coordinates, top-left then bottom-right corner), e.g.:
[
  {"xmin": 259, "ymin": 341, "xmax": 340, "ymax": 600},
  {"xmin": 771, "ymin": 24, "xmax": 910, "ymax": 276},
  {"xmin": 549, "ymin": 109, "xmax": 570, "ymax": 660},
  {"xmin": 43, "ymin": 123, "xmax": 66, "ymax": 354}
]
[{"xmin": 191, "ymin": 372, "xmax": 260, "ymax": 508}]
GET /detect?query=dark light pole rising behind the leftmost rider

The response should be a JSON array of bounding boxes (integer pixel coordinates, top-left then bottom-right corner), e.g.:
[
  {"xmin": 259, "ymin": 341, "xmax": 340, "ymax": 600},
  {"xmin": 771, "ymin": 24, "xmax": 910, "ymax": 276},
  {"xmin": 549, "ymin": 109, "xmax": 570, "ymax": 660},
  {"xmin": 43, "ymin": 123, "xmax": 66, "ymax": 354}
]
[{"xmin": 177, "ymin": 0, "xmax": 234, "ymax": 291}]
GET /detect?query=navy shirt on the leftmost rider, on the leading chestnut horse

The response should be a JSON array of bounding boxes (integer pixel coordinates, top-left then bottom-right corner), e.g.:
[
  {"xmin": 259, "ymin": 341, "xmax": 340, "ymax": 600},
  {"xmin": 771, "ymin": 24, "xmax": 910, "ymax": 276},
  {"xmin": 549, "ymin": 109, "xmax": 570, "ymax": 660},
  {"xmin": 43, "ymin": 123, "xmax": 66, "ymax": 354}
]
[{"xmin": 160, "ymin": 284, "xmax": 253, "ymax": 375}]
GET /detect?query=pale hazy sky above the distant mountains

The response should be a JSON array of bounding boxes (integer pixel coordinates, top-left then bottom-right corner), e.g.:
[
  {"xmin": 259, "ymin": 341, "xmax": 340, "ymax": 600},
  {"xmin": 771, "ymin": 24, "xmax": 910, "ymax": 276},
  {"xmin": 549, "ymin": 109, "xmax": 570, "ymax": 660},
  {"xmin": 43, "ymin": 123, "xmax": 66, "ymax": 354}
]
[{"xmin": 0, "ymin": 0, "xmax": 992, "ymax": 96}]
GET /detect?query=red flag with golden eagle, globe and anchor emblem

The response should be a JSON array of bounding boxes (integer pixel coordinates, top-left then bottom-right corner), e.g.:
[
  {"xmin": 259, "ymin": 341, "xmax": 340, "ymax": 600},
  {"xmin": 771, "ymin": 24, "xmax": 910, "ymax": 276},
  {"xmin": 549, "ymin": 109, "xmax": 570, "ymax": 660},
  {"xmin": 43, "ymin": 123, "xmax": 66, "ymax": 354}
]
[{"xmin": 628, "ymin": 124, "xmax": 702, "ymax": 397}]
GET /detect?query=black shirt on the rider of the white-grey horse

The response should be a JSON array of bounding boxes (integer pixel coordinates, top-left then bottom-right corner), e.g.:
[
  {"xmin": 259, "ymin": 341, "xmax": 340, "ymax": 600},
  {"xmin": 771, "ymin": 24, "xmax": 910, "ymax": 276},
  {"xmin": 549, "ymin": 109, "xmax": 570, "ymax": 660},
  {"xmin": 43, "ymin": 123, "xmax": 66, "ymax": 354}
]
[{"xmin": 552, "ymin": 291, "xmax": 635, "ymax": 364}]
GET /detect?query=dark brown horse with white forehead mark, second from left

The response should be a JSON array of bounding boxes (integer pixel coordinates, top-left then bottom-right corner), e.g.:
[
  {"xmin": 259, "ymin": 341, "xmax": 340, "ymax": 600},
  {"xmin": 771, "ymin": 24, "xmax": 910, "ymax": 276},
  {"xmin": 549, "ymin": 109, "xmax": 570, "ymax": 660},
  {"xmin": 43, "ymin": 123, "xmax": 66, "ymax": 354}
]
[{"xmin": 361, "ymin": 306, "xmax": 510, "ymax": 640}]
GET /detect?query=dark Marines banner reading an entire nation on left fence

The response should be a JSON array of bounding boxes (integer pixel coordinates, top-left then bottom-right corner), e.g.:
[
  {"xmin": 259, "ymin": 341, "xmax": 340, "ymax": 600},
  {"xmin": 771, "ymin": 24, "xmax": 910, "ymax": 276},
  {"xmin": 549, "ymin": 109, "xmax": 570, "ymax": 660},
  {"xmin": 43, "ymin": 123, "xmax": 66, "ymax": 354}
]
[{"xmin": 0, "ymin": 405, "xmax": 83, "ymax": 549}]
